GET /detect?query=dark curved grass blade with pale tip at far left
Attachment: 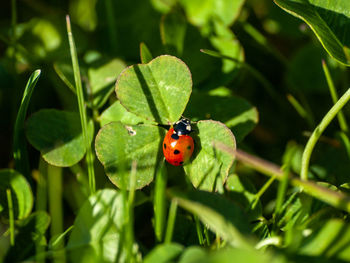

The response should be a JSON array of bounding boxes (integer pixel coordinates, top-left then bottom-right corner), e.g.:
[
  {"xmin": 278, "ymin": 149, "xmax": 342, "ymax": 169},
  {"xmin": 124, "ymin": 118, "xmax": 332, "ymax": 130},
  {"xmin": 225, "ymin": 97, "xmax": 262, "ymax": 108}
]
[{"xmin": 13, "ymin": 69, "xmax": 41, "ymax": 179}]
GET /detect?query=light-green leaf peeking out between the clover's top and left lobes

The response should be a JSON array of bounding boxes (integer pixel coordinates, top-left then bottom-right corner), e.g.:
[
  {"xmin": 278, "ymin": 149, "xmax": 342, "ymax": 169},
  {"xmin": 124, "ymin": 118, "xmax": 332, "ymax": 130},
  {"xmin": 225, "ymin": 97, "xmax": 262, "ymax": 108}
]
[{"xmin": 100, "ymin": 100, "xmax": 152, "ymax": 127}]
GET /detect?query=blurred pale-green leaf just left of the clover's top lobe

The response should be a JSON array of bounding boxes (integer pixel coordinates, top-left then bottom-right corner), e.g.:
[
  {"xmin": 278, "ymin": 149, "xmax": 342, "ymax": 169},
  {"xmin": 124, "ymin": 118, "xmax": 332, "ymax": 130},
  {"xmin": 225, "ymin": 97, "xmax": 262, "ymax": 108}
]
[{"xmin": 88, "ymin": 59, "xmax": 126, "ymax": 108}]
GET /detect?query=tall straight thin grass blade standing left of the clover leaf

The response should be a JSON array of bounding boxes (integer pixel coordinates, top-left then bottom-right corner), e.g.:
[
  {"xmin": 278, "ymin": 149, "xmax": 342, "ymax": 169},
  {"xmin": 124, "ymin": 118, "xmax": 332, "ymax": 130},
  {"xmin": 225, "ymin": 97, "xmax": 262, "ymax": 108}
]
[{"xmin": 66, "ymin": 15, "xmax": 96, "ymax": 194}]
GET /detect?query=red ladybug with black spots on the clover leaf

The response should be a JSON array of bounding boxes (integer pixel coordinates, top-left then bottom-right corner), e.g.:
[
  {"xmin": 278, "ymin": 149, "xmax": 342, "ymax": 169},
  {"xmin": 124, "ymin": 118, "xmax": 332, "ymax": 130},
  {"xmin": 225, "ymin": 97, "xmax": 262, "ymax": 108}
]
[{"xmin": 163, "ymin": 118, "xmax": 194, "ymax": 166}]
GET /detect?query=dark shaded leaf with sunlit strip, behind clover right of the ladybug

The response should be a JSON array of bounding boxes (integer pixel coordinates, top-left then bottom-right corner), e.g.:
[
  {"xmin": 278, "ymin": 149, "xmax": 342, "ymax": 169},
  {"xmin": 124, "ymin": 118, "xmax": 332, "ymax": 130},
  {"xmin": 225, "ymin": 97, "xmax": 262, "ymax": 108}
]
[{"xmin": 184, "ymin": 92, "xmax": 259, "ymax": 142}]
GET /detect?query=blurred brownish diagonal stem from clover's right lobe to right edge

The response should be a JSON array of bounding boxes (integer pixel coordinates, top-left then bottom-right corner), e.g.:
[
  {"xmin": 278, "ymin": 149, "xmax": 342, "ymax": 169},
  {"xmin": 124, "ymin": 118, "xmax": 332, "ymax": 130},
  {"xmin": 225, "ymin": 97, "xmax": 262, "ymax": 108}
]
[{"xmin": 236, "ymin": 149, "xmax": 350, "ymax": 212}]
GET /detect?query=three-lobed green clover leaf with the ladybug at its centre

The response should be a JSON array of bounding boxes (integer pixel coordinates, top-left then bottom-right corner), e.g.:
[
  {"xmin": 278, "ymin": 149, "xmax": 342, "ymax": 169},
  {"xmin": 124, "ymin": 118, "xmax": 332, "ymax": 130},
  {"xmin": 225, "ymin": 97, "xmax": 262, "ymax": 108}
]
[{"xmin": 95, "ymin": 55, "xmax": 252, "ymax": 191}]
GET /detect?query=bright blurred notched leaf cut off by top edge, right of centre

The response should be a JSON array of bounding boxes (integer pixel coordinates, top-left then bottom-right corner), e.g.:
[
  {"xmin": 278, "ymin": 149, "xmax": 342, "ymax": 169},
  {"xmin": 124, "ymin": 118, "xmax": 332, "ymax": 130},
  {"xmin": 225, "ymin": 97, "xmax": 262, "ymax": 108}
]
[{"xmin": 180, "ymin": 0, "xmax": 244, "ymax": 27}]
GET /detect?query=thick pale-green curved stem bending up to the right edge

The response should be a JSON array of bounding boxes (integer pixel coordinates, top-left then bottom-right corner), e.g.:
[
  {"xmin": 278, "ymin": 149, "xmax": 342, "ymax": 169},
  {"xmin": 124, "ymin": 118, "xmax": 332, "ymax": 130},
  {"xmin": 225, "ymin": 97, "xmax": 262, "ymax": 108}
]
[{"xmin": 300, "ymin": 89, "xmax": 350, "ymax": 180}]
